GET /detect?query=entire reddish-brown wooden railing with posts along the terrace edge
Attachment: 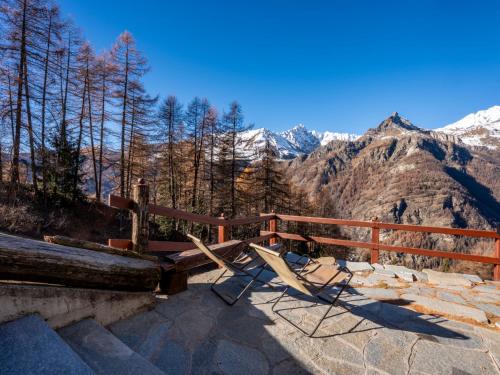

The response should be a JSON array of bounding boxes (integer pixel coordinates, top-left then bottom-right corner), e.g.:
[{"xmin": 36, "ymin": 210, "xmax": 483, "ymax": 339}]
[{"xmin": 109, "ymin": 181, "xmax": 500, "ymax": 280}]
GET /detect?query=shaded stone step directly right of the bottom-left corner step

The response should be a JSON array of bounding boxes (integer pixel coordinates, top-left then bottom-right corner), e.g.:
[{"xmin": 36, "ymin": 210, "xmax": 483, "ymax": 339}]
[{"xmin": 59, "ymin": 319, "xmax": 164, "ymax": 375}]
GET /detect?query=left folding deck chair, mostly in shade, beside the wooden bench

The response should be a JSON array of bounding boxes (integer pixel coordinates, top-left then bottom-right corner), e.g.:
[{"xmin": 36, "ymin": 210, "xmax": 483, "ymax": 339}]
[{"xmin": 187, "ymin": 234, "xmax": 266, "ymax": 306}]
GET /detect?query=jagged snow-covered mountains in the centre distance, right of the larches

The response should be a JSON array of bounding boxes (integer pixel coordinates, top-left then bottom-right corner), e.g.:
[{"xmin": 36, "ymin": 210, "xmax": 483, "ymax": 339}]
[{"xmin": 239, "ymin": 124, "xmax": 359, "ymax": 159}]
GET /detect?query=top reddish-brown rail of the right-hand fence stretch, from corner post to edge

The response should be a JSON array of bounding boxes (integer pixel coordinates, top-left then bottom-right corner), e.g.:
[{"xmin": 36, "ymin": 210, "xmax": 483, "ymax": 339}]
[{"xmin": 276, "ymin": 214, "xmax": 500, "ymax": 238}]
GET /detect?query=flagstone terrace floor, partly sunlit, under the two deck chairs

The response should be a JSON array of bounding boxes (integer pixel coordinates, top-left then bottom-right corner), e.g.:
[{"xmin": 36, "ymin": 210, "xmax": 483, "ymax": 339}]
[{"xmin": 120, "ymin": 264, "xmax": 500, "ymax": 374}]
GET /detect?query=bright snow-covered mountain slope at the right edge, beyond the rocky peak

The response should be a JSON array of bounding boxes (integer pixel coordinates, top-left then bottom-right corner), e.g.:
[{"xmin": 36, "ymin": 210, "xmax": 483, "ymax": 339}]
[{"xmin": 434, "ymin": 106, "xmax": 500, "ymax": 149}]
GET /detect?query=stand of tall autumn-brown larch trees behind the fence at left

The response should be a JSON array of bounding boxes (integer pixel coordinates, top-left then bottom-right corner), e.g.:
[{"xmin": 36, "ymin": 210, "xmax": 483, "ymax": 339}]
[{"xmin": 0, "ymin": 0, "xmax": 306, "ymax": 223}]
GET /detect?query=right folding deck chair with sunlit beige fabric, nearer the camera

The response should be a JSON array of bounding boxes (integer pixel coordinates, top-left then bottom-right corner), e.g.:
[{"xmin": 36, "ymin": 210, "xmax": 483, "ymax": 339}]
[{"xmin": 250, "ymin": 243, "xmax": 352, "ymax": 337}]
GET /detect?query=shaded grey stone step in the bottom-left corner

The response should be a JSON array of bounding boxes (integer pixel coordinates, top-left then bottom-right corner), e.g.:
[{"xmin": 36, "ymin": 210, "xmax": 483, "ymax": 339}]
[{"xmin": 0, "ymin": 314, "xmax": 93, "ymax": 375}]
